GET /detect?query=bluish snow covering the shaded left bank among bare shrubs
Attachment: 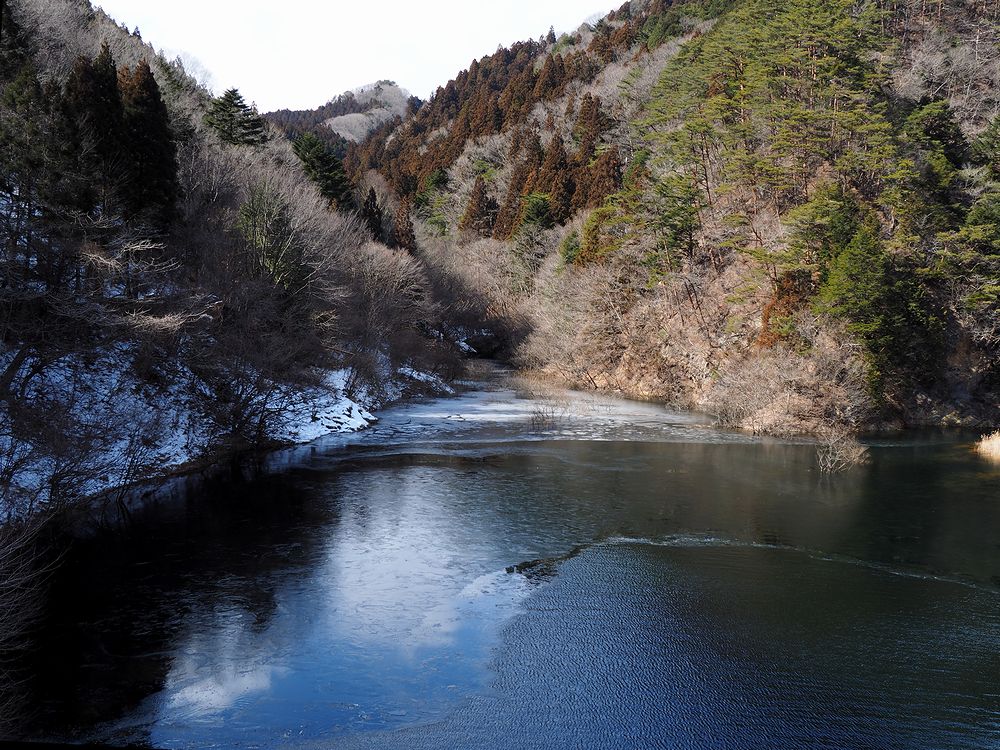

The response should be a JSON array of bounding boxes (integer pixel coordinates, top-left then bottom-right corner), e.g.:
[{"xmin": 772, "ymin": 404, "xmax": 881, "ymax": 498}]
[{"xmin": 0, "ymin": 346, "xmax": 454, "ymax": 520}]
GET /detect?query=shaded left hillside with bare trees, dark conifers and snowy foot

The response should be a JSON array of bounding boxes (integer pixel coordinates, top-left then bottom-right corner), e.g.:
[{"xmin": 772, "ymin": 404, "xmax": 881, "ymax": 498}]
[{"xmin": 0, "ymin": 0, "xmax": 458, "ymax": 518}]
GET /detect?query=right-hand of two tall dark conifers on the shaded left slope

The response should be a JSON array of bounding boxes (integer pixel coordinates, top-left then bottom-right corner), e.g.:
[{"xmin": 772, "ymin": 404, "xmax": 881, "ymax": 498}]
[{"xmin": 119, "ymin": 60, "xmax": 177, "ymax": 229}]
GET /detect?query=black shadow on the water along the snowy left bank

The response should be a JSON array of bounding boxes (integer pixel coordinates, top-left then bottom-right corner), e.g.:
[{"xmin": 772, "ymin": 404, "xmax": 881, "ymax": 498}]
[{"xmin": 15, "ymin": 474, "xmax": 337, "ymax": 741}]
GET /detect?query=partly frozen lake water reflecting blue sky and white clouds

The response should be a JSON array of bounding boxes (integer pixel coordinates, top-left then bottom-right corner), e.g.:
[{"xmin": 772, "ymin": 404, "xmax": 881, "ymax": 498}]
[{"xmin": 13, "ymin": 378, "xmax": 1000, "ymax": 749}]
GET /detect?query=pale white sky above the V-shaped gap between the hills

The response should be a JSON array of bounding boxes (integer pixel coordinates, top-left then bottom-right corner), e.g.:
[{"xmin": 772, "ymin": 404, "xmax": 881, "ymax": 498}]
[{"xmin": 95, "ymin": 0, "xmax": 621, "ymax": 111}]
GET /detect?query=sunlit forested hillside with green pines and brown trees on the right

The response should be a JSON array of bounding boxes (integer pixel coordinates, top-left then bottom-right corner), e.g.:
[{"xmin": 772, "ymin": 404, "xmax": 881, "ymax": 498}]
[{"xmin": 345, "ymin": 0, "xmax": 1000, "ymax": 433}]
